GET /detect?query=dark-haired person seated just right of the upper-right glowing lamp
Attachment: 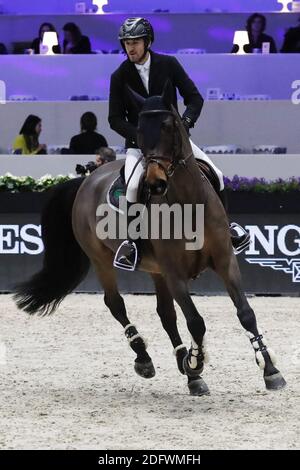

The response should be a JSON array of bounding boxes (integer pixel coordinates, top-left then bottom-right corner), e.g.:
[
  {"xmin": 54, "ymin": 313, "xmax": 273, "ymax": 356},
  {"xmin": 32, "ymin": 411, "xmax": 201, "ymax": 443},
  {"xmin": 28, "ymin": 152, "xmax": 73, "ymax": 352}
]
[{"xmin": 231, "ymin": 13, "xmax": 277, "ymax": 54}]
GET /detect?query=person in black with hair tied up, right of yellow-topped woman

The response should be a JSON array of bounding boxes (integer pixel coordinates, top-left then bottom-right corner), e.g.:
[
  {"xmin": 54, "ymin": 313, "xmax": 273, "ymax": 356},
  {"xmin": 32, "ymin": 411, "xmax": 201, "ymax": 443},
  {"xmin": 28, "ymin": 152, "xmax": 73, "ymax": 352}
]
[{"xmin": 70, "ymin": 111, "xmax": 107, "ymax": 155}]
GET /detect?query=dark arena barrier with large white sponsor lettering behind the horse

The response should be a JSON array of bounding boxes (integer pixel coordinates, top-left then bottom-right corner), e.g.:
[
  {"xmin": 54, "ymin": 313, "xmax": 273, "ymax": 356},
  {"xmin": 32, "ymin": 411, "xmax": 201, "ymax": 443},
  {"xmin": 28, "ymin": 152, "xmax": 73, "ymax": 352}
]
[{"xmin": 0, "ymin": 194, "xmax": 300, "ymax": 295}]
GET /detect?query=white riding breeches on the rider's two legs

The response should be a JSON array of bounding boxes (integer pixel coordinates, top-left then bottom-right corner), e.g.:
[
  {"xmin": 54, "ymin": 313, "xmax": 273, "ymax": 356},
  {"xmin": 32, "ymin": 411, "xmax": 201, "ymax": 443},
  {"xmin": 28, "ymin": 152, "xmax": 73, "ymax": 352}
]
[{"xmin": 125, "ymin": 140, "xmax": 224, "ymax": 202}]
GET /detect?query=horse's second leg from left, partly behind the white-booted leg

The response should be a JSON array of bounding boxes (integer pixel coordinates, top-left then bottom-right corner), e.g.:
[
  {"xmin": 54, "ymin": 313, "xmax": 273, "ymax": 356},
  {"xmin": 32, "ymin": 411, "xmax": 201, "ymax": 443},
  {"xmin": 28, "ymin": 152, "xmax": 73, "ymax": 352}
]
[{"xmin": 151, "ymin": 274, "xmax": 188, "ymax": 374}]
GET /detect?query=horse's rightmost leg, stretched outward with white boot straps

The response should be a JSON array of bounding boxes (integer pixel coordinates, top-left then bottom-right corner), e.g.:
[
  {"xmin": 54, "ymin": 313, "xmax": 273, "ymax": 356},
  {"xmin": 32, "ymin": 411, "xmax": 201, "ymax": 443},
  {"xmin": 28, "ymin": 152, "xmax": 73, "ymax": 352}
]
[{"xmin": 215, "ymin": 254, "xmax": 286, "ymax": 390}]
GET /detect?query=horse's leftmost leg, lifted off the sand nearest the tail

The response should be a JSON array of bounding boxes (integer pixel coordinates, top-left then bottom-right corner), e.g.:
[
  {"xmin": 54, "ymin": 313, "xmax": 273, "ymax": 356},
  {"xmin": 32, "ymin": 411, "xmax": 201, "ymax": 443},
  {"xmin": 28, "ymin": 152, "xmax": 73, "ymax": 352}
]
[{"xmin": 92, "ymin": 248, "xmax": 155, "ymax": 379}]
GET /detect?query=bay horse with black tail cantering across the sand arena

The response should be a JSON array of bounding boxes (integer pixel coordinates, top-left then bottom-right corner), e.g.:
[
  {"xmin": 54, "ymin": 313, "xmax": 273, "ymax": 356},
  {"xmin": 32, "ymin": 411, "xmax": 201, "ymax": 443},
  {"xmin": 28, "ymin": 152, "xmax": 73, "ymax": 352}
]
[{"xmin": 15, "ymin": 86, "xmax": 286, "ymax": 396}]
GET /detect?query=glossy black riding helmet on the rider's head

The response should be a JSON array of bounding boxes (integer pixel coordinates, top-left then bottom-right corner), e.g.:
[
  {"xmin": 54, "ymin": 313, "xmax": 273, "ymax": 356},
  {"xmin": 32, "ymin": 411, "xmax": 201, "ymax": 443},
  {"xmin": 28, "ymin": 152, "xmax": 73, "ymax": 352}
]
[{"xmin": 119, "ymin": 18, "xmax": 154, "ymax": 52}]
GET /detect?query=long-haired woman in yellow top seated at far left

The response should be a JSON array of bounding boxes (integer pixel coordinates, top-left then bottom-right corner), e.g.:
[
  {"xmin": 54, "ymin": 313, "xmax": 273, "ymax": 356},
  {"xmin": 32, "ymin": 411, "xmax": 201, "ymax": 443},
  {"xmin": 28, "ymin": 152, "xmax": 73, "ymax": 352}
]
[{"xmin": 13, "ymin": 114, "xmax": 47, "ymax": 155}]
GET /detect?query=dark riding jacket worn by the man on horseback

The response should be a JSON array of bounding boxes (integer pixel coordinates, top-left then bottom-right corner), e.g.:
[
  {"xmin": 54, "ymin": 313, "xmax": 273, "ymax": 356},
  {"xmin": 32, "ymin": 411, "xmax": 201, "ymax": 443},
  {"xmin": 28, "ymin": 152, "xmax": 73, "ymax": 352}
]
[{"xmin": 108, "ymin": 51, "xmax": 203, "ymax": 148}]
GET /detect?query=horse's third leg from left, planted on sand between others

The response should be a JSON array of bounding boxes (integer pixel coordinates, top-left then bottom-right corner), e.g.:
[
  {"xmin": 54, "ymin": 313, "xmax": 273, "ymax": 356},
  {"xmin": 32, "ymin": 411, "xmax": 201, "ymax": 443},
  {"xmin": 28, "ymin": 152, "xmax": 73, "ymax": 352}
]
[{"xmin": 165, "ymin": 274, "xmax": 209, "ymax": 396}]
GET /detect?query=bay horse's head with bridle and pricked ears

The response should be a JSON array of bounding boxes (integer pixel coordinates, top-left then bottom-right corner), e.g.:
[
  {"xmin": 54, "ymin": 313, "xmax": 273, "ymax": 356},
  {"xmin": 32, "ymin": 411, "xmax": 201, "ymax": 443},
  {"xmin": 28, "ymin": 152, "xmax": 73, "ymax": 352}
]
[{"xmin": 127, "ymin": 82, "xmax": 192, "ymax": 195}]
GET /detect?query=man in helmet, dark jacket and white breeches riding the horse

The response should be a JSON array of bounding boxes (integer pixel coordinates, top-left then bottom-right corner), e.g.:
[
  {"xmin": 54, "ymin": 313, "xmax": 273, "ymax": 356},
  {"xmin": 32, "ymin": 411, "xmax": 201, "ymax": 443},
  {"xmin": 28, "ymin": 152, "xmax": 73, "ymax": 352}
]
[{"xmin": 108, "ymin": 18, "xmax": 250, "ymax": 270}]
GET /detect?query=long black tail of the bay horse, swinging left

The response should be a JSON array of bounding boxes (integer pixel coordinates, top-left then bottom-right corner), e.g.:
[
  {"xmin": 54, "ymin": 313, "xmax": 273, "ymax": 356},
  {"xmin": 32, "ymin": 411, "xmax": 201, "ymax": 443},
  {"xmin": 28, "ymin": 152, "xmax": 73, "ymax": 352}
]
[{"xmin": 14, "ymin": 178, "xmax": 90, "ymax": 315}]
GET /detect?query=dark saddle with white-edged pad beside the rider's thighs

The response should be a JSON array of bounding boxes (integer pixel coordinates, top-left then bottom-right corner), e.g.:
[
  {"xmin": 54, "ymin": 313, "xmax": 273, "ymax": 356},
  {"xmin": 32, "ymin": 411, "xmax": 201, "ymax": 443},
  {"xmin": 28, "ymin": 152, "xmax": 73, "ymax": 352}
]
[{"xmin": 107, "ymin": 160, "xmax": 220, "ymax": 212}]
